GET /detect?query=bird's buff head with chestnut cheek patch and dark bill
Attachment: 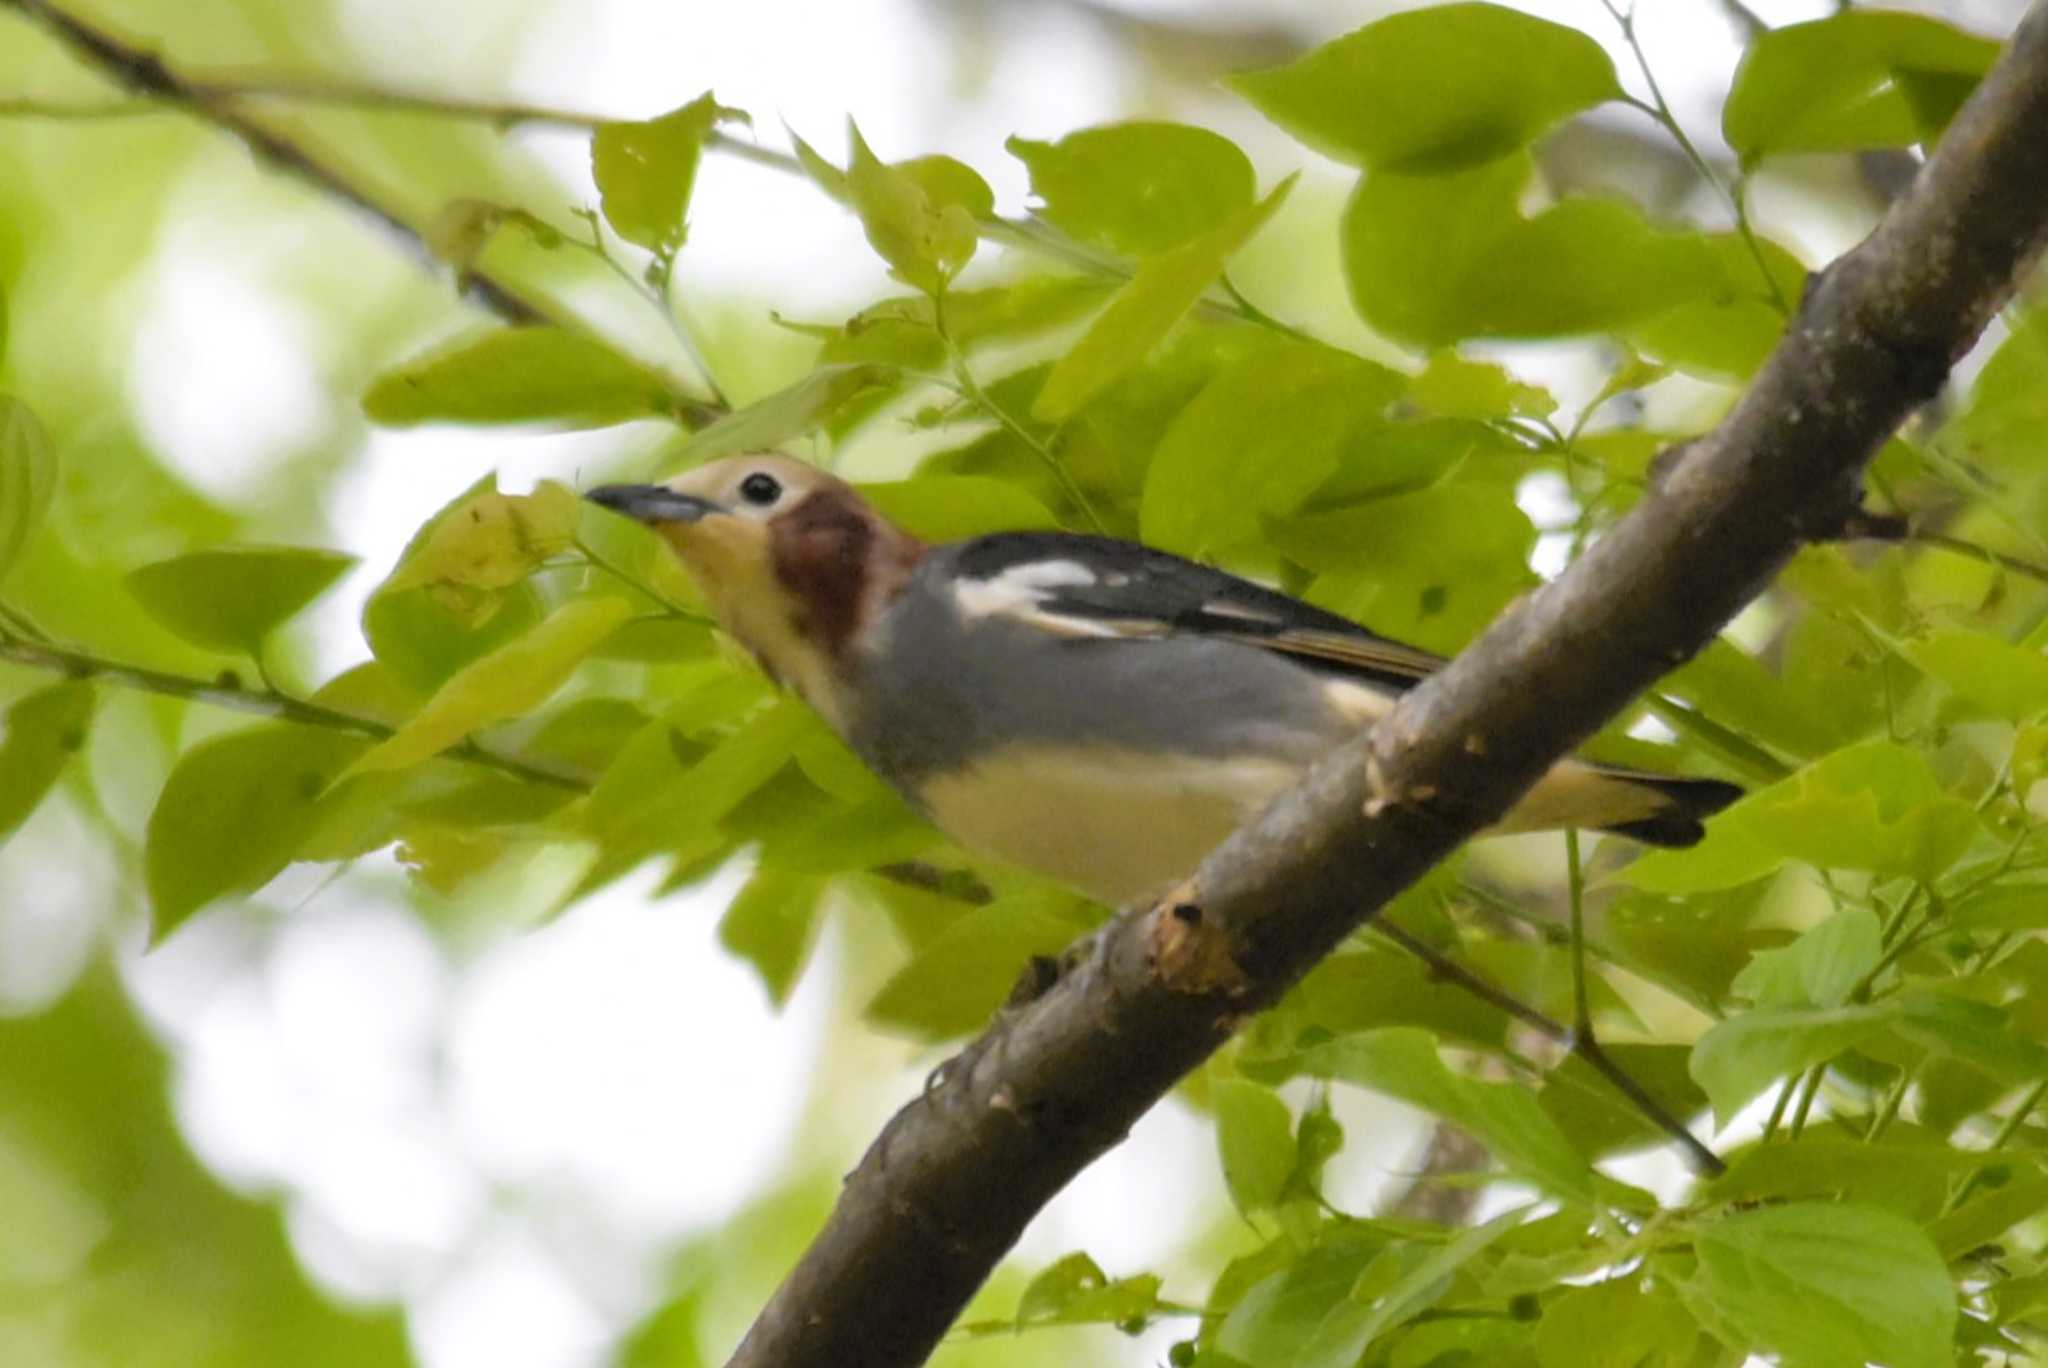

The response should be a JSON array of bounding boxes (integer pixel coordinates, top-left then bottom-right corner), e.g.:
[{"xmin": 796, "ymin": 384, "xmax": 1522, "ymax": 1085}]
[{"xmin": 586, "ymin": 455, "xmax": 924, "ymax": 719}]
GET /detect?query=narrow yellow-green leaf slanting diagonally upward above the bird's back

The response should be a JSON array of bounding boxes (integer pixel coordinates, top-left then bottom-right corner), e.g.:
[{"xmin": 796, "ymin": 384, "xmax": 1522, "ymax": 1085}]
[{"xmin": 1032, "ymin": 176, "xmax": 1294, "ymax": 424}]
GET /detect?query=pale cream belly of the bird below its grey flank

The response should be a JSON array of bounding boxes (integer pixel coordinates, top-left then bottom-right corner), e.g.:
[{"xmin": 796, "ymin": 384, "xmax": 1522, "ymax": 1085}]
[{"xmin": 920, "ymin": 745, "xmax": 1300, "ymax": 907}]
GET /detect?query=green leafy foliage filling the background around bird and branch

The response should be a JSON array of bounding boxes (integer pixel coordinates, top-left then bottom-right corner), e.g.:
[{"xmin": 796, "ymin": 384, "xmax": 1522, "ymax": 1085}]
[{"xmin": 0, "ymin": 4, "xmax": 2048, "ymax": 1368}]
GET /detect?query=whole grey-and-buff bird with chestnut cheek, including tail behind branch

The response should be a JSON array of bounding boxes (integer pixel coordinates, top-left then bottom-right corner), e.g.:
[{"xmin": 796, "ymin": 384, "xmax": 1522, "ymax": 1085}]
[{"xmin": 586, "ymin": 453, "xmax": 1741, "ymax": 907}]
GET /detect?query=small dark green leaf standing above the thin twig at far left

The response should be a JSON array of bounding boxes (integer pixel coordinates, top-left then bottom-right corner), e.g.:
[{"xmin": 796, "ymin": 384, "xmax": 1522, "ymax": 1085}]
[{"xmin": 127, "ymin": 547, "xmax": 356, "ymax": 655}]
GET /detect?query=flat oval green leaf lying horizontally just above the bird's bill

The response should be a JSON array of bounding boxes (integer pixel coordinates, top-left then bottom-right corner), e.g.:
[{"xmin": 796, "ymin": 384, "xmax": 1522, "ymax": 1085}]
[{"xmin": 362, "ymin": 324, "xmax": 676, "ymax": 428}]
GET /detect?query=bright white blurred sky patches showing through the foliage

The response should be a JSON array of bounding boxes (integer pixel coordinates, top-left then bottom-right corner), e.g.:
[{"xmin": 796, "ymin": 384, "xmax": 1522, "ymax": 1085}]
[{"xmin": 28, "ymin": 0, "xmax": 2009, "ymax": 1368}]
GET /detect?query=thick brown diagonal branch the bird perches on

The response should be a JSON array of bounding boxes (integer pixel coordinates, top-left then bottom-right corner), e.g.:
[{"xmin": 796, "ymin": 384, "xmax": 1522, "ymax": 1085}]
[{"xmin": 731, "ymin": 6, "xmax": 2048, "ymax": 1368}]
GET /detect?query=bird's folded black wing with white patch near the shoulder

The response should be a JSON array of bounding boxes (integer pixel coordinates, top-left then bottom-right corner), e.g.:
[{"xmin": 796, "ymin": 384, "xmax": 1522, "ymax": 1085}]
[{"xmin": 956, "ymin": 532, "xmax": 1444, "ymax": 690}]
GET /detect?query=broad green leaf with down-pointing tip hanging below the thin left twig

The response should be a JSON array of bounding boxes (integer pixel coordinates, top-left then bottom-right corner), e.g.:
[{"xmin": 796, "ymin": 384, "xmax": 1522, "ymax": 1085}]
[{"xmin": 143, "ymin": 725, "xmax": 369, "ymax": 940}]
